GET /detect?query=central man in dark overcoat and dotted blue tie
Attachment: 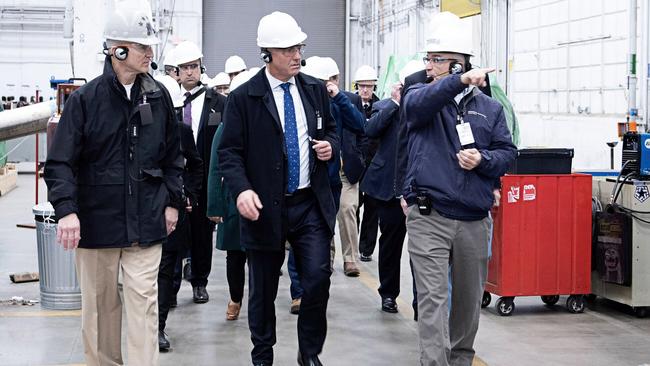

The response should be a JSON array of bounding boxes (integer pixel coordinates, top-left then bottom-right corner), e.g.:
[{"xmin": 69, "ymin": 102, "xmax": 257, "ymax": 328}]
[{"xmin": 218, "ymin": 12, "xmax": 338, "ymax": 366}]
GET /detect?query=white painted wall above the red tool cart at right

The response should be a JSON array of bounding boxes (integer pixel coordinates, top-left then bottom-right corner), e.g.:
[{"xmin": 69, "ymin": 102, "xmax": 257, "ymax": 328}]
[{"xmin": 508, "ymin": 0, "xmax": 632, "ymax": 169}]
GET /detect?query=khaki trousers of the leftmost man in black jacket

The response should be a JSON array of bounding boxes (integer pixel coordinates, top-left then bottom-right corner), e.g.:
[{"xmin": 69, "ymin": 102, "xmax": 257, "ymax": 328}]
[{"xmin": 76, "ymin": 245, "xmax": 162, "ymax": 366}]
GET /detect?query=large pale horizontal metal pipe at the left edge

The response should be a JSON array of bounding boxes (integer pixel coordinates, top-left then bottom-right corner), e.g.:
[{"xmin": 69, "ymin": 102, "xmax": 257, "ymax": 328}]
[{"xmin": 0, "ymin": 100, "xmax": 56, "ymax": 141}]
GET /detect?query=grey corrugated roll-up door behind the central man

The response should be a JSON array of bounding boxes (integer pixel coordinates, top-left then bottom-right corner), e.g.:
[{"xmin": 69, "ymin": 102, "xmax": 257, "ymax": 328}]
[{"xmin": 203, "ymin": 0, "xmax": 345, "ymax": 80}]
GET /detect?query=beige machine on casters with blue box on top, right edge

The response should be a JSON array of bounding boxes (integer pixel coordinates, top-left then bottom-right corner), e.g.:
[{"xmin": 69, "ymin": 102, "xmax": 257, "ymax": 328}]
[{"xmin": 591, "ymin": 156, "xmax": 650, "ymax": 317}]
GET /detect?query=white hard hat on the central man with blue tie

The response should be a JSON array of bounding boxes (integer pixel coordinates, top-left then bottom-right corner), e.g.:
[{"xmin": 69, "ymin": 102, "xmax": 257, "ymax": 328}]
[{"xmin": 257, "ymin": 11, "xmax": 307, "ymax": 48}]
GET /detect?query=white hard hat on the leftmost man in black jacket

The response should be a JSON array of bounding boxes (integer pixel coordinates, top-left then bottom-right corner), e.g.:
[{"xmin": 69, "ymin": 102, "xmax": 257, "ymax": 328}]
[{"xmin": 104, "ymin": 0, "xmax": 160, "ymax": 46}]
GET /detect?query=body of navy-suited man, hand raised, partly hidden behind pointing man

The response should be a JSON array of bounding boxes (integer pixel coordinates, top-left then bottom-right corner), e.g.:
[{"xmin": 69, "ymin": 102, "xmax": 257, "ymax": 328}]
[{"xmin": 361, "ymin": 84, "xmax": 406, "ymax": 313}]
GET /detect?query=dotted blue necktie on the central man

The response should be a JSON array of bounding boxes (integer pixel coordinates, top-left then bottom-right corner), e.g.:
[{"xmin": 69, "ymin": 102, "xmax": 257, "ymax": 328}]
[{"xmin": 280, "ymin": 83, "xmax": 300, "ymax": 193}]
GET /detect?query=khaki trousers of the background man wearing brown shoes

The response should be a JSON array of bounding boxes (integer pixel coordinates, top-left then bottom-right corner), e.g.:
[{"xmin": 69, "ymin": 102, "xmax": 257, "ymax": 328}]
[{"xmin": 331, "ymin": 173, "xmax": 359, "ymax": 263}]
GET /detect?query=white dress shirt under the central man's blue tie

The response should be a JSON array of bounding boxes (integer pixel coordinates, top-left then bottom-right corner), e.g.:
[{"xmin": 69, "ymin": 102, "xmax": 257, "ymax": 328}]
[{"xmin": 266, "ymin": 68, "xmax": 310, "ymax": 189}]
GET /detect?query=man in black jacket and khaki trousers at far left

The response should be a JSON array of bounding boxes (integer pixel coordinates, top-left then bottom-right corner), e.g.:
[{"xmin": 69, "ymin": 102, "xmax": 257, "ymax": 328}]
[{"xmin": 45, "ymin": 2, "xmax": 184, "ymax": 365}]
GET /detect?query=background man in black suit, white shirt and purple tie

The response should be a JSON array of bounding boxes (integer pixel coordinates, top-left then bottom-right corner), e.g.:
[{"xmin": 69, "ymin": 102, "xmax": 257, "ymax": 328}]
[{"xmin": 174, "ymin": 41, "xmax": 226, "ymax": 304}]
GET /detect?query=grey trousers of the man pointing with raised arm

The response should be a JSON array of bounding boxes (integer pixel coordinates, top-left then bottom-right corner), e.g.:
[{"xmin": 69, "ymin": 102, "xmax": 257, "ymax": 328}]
[{"xmin": 406, "ymin": 205, "xmax": 491, "ymax": 366}]
